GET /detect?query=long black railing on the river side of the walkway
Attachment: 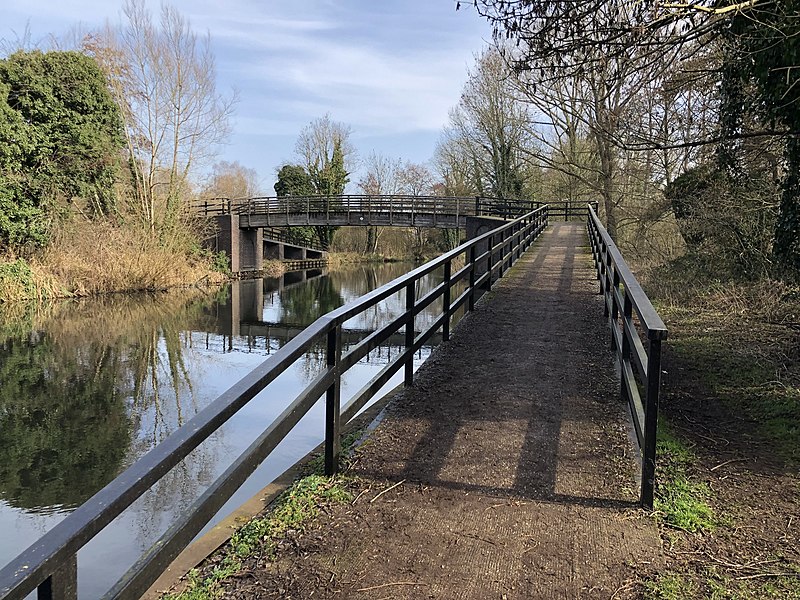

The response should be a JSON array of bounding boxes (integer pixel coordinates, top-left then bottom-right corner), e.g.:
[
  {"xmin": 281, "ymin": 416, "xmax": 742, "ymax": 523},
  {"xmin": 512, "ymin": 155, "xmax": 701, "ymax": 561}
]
[{"xmin": 0, "ymin": 206, "xmax": 548, "ymax": 600}]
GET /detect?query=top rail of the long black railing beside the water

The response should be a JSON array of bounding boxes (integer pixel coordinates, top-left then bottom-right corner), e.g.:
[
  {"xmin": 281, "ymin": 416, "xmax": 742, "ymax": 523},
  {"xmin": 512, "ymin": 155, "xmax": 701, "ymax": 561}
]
[{"xmin": 0, "ymin": 205, "xmax": 547, "ymax": 599}]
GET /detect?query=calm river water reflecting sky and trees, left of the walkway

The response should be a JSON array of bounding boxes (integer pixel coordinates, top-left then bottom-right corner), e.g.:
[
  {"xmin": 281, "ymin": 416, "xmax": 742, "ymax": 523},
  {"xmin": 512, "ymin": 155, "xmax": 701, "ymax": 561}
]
[{"xmin": 0, "ymin": 263, "xmax": 456, "ymax": 597}]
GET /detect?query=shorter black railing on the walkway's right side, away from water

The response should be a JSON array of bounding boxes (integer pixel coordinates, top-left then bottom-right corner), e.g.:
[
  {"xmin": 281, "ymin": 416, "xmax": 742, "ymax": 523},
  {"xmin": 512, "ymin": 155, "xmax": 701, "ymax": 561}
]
[{"xmin": 588, "ymin": 206, "xmax": 667, "ymax": 509}]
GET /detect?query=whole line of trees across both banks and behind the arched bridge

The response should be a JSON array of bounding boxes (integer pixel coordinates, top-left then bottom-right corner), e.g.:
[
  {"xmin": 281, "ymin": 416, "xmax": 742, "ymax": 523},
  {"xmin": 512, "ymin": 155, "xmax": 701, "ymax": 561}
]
[{"xmin": 0, "ymin": 0, "xmax": 800, "ymax": 277}]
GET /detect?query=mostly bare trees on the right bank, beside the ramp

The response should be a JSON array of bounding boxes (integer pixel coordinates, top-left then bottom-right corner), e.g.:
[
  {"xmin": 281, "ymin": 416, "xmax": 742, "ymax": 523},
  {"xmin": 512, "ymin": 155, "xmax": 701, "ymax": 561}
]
[{"xmin": 457, "ymin": 0, "xmax": 800, "ymax": 278}]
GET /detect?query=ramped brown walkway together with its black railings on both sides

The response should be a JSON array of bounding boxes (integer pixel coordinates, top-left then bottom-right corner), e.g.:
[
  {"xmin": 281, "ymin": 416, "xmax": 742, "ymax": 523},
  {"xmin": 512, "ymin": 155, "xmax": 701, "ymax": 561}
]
[{"xmin": 0, "ymin": 205, "xmax": 667, "ymax": 600}]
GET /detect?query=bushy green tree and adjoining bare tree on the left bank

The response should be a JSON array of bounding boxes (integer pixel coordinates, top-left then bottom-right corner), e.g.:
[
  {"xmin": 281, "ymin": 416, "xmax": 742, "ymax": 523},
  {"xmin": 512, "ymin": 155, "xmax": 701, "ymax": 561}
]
[{"xmin": 0, "ymin": 0, "xmax": 236, "ymax": 252}]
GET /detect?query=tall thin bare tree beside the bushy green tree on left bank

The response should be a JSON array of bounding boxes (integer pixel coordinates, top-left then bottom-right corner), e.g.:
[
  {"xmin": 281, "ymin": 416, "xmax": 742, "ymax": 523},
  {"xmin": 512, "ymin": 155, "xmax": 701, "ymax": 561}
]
[{"xmin": 89, "ymin": 0, "xmax": 235, "ymax": 230}]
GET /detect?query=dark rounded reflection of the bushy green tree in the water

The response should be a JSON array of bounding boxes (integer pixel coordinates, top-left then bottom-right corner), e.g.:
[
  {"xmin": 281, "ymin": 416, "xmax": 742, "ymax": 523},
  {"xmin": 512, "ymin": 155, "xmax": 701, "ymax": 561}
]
[{"xmin": 0, "ymin": 335, "xmax": 131, "ymax": 511}]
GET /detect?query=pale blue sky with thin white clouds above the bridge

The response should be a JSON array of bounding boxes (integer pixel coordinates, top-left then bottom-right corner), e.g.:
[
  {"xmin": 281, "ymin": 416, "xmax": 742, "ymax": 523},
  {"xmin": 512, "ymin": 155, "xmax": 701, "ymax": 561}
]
[{"xmin": 0, "ymin": 0, "xmax": 491, "ymax": 194}]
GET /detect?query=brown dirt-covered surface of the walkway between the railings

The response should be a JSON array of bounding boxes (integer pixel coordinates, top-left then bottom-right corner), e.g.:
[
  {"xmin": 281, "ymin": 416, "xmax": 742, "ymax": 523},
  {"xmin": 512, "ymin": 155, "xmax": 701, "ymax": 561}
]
[{"xmin": 226, "ymin": 223, "xmax": 663, "ymax": 600}]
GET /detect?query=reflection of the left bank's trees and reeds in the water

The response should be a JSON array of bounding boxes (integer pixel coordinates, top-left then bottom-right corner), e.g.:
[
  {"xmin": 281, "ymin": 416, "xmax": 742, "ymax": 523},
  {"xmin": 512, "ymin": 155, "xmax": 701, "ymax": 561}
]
[{"xmin": 0, "ymin": 293, "xmax": 222, "ymax": 512}]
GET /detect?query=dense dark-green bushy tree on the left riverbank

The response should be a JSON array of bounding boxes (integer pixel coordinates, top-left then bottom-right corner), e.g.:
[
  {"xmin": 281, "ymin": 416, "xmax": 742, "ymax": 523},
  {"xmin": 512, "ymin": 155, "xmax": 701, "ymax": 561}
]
[{"xmin": 0, "ymin": 50, "xmax": 123, "ymax": 246}]
